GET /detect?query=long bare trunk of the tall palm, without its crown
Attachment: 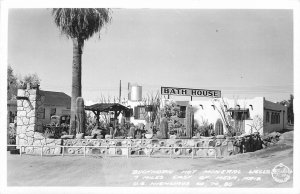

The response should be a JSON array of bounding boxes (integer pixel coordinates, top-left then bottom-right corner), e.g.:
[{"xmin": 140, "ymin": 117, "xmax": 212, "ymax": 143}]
[{"xmin": 69, "ymin": 38, "xmax": 83, "ymax": 135}]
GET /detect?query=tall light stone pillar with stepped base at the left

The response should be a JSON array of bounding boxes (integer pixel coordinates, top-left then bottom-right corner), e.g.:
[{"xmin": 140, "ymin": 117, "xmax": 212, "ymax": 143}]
[{"xmin": 16, "ymin": 87, "xmax": 62, "ymax": 154}]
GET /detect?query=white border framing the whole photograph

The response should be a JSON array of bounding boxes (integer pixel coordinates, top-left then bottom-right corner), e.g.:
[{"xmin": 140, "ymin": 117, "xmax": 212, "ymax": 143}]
[{"xmin": 0, "ymin": 0, "xmax": 300, "ymax": 194}]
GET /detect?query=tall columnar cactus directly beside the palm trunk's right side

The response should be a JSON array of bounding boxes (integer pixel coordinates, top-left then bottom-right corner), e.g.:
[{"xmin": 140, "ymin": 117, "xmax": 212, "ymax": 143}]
[{"xmin": 75, "ymin": 97, "xmax": 86, "ymax": 133}]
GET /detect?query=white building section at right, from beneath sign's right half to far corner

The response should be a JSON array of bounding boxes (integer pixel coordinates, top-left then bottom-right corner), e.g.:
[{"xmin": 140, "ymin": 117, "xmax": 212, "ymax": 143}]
[{"xmin": 188, "ymin": 97, "xmax": 287, "ymax": 134}]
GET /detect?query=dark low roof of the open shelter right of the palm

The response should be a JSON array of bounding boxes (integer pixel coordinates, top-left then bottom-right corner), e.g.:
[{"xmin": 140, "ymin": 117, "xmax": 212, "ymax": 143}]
[{"xmin": 85, "ymin": 103, "xmax": 129, "ymax": 112}]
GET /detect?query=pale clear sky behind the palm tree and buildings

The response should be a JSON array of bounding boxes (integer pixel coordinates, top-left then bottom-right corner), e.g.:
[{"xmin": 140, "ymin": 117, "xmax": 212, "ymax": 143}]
[{"xmin": 8, "ymin": 9, "xmax": 294, "ymax": 102}]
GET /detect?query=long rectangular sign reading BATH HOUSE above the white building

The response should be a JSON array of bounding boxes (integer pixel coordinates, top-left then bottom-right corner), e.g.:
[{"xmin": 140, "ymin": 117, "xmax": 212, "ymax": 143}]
[{"xmin": 161, "ymin": 87, "xmax": 221, "ymax": 98}]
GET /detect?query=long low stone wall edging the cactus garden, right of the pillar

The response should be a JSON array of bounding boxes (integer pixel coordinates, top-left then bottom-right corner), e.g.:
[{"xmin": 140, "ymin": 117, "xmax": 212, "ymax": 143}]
[{"xmin": 63, "ymin": 136, "xmax": 262, "ymax": 157}]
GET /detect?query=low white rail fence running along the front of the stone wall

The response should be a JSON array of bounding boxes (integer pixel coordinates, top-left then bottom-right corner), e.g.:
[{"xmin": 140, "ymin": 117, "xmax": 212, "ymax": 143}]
[{"xmin": 7, "ymin": 145, "xmax": 217, "ymax": 159}]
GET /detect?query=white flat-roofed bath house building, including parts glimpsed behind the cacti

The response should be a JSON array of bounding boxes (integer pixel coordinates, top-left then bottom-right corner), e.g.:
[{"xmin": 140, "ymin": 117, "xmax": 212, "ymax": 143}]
[{"xmin": 123, "ymin": 97, "xmax": 287, "ymax": 134}]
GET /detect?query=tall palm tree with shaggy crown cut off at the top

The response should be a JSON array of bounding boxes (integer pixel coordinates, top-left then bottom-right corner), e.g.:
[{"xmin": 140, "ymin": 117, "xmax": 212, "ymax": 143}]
[{"xmin": 52, "ymin": 8, "xmax": 111, "ymax": 134}]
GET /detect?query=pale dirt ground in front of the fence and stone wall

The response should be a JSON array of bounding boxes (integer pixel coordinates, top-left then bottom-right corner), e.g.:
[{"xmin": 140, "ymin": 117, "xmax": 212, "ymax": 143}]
[{"xmin": 7, "ymin": 133, "xmax": 293, "ymax": 188}]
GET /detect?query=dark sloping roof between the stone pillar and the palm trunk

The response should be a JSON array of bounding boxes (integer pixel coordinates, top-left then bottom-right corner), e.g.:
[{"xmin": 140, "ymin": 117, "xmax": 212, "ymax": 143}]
[{"xmin": 40, "ymin": 90, "xmax": 71, "ymax": 108}]
